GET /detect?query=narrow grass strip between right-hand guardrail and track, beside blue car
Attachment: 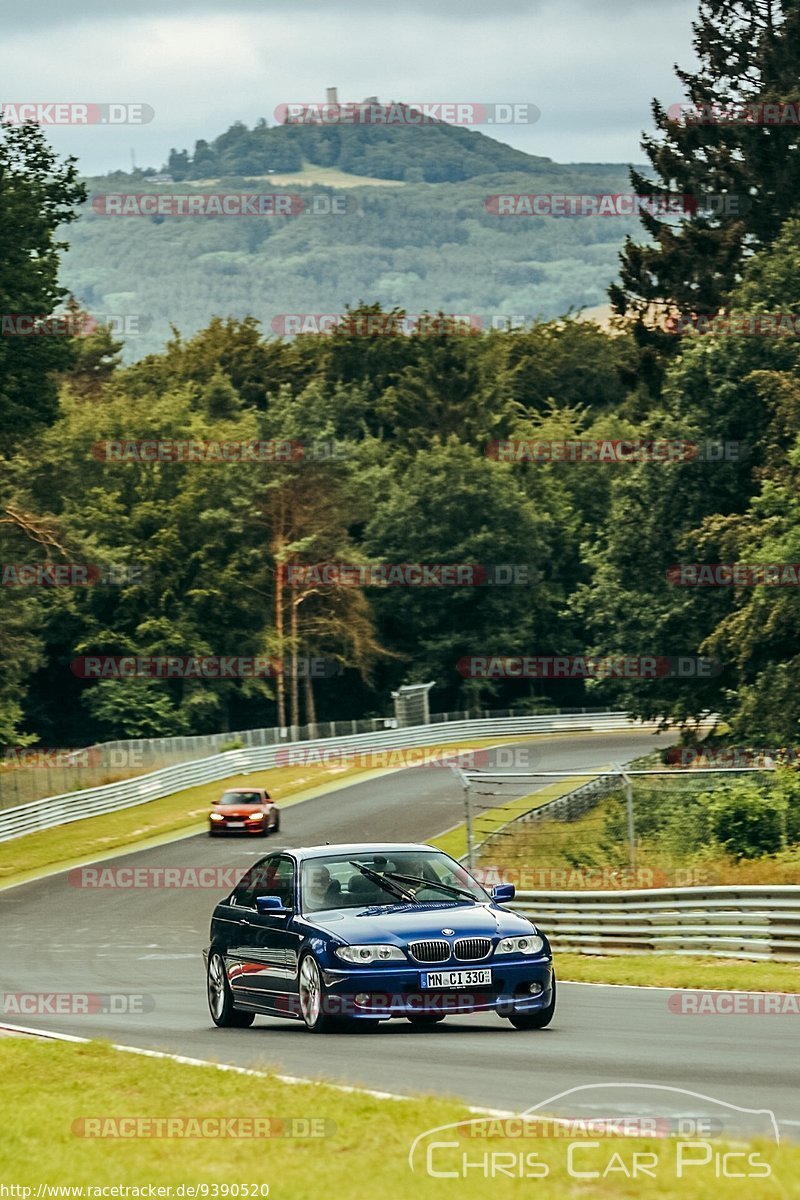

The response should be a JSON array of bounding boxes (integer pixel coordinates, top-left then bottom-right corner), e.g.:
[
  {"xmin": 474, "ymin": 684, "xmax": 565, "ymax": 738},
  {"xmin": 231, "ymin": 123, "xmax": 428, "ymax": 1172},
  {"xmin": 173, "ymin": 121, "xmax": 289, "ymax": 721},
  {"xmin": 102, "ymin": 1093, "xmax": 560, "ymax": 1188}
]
[{"xmin": 554, "ymin": 949, "xmax": 800, "ymax": 992}]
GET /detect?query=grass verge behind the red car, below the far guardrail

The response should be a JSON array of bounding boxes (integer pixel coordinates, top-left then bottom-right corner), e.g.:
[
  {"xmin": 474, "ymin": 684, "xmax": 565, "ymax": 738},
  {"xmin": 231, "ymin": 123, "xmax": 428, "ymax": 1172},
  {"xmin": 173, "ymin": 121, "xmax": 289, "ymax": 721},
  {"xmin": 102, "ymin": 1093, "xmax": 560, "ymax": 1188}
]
[{"xmin": 0, "ymin": 737, "xmax": 544, "ymax": 883}]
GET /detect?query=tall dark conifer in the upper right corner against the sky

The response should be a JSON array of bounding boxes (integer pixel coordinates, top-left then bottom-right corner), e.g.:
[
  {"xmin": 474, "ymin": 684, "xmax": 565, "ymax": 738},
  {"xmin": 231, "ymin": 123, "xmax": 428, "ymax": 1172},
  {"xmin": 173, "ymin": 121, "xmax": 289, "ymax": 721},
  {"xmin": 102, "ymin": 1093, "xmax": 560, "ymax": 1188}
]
[{"xmin": 609, "ymin": 0, "xmax": 800, "ymax": 324}]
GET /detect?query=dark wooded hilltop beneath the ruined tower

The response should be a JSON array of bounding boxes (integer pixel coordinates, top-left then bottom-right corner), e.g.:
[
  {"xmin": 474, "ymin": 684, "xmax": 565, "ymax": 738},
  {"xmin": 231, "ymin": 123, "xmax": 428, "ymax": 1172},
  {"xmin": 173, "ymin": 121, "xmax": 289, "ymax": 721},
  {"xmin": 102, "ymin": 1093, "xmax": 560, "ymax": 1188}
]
[{"xmin": 164, "ymin": 104, "xmax": 551, "ymax": 184}]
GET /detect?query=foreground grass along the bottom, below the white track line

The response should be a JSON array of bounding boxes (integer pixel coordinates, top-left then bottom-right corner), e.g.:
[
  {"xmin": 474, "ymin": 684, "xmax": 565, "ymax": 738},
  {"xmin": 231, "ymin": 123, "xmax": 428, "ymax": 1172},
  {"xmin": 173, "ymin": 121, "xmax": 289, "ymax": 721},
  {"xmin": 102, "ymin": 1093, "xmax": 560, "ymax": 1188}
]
[{"xmin": 0, "ymin": 1033, "xmax": 800, "ymax": 1200}]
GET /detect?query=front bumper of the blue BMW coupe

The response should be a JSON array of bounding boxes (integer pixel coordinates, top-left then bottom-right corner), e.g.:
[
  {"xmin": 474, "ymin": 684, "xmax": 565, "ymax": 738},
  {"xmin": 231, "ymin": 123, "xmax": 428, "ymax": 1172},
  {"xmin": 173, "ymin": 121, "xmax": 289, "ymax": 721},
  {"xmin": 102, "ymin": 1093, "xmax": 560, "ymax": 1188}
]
[{"xmin": 311, "ymin": 958, "xmax": 554, "ymax": 1020}]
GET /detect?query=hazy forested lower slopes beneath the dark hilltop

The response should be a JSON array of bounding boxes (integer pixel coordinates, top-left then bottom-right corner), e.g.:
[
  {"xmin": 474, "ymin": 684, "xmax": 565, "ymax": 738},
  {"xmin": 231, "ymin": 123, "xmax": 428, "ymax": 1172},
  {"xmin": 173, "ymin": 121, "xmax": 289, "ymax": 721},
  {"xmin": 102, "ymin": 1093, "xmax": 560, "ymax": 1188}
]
[{"xmin": 61, "ymin": 116, "xmax": 639, "ymax": 359}]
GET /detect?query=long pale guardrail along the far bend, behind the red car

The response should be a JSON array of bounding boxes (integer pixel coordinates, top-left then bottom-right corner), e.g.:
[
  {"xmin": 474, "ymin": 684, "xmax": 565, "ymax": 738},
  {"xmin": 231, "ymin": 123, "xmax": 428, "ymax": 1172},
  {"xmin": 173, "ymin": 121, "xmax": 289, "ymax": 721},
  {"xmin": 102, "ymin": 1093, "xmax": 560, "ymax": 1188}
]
[{"xmin": 0, "ymin": 713, "xmax": 658, "ymax": 841}]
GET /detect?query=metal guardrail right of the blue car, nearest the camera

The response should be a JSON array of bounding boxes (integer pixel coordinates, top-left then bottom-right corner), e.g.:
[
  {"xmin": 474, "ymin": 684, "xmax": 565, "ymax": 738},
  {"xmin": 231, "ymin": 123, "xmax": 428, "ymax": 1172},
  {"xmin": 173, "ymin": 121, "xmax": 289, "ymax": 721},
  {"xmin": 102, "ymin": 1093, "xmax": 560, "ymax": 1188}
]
[{"xmin": 510, "ymin": 886, "xmax": 800, "ymax": 961}]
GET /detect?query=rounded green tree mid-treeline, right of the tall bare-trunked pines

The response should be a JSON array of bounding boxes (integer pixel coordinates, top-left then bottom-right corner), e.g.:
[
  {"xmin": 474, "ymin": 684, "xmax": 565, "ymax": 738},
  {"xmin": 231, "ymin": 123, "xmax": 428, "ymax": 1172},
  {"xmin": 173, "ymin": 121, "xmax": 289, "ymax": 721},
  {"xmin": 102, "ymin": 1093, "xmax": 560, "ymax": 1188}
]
[{"xmin": 362, "ymin": 437, "xmax": 563, "ymax": 707}]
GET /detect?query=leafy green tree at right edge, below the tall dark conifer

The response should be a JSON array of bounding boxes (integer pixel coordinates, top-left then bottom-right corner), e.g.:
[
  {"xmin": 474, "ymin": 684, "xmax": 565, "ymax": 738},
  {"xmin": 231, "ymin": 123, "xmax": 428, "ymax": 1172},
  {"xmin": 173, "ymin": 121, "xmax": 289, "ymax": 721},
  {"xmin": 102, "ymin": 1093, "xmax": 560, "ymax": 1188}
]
[{"xmin": 573, "ymin": 214, "xmax": 800, "ymax": 736}]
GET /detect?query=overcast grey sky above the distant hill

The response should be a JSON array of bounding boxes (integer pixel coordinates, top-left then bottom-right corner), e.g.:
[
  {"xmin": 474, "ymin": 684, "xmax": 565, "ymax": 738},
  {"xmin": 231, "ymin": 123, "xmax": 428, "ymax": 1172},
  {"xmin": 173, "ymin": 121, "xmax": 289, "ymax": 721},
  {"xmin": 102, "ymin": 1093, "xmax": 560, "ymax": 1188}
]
[{"xmin": 0, "ymin": 0, "xmax": 698, "ymax": 174}]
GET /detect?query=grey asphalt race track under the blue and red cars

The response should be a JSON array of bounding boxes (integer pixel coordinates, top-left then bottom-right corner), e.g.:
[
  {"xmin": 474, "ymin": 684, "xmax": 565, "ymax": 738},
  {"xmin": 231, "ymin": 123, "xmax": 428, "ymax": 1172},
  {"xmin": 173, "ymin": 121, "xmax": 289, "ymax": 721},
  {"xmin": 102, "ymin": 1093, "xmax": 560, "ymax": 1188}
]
[{"xmin": 0, "ymin": 732, "xmax": 800, "ymax": 1136}]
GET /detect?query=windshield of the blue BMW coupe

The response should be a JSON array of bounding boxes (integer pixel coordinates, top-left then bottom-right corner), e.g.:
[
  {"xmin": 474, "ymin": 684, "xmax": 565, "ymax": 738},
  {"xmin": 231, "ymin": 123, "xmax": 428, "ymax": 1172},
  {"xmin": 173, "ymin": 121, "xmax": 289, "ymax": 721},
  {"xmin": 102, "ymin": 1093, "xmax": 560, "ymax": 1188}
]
[{"xmin": 300, "ymin": 850, "xmax": 488, "ymax": 912}]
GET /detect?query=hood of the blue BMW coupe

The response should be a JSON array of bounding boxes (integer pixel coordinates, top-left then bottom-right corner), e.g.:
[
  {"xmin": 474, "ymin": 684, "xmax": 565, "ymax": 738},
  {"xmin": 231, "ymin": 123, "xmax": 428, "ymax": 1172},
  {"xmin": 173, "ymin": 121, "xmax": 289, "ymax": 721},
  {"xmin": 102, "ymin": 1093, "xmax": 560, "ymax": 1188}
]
[{"xmin": 306, "ymin": 900, "xmax": 531, "ymax": 946}]
